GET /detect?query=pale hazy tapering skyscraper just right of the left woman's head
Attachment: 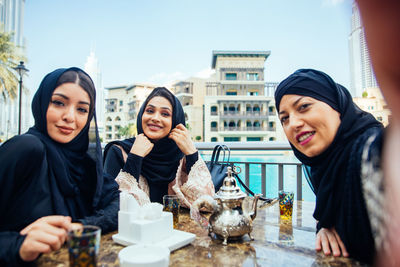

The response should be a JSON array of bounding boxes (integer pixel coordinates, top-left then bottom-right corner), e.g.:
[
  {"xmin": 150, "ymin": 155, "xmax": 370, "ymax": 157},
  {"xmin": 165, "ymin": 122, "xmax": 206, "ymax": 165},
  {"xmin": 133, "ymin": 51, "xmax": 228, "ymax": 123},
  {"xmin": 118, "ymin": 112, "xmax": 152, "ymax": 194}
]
[{"xmin": 84, "ymin": 50, "xmax": 105, "ymax": 140}]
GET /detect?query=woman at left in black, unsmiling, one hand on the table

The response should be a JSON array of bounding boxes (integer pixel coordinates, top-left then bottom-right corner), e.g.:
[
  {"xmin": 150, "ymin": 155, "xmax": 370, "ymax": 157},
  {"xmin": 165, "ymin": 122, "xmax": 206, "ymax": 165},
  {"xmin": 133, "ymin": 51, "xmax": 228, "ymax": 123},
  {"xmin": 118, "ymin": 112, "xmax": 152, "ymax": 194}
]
[{"xmin": 0, "ymin": 68, "xmax": 118, "ymax": 266}]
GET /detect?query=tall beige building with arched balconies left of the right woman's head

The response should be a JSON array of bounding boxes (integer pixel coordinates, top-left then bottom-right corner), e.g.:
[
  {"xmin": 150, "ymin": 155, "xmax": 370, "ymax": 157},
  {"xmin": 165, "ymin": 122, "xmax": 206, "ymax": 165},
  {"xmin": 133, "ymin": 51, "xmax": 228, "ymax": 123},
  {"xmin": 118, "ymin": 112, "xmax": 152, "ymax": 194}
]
[{"xmin": 203, "ymin": 51, "xmax": 284, "ymax": 142}]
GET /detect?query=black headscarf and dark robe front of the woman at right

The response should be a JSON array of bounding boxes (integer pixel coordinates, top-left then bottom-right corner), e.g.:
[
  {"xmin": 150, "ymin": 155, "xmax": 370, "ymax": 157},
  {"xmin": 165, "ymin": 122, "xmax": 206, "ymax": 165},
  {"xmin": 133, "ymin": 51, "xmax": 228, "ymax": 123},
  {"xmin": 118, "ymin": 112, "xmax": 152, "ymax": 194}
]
[{"xmin": 275, "ymin": 69, "xmax": 383, "ymax": 261}]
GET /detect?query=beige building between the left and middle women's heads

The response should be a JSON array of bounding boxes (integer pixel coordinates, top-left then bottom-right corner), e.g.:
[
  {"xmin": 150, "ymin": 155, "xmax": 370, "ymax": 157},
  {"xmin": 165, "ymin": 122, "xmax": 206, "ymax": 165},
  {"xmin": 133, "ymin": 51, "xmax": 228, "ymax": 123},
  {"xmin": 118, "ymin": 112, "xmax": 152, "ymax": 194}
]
[{"xmin": 104, "ymin": 84, "xmax": 156, "ymax": 142}]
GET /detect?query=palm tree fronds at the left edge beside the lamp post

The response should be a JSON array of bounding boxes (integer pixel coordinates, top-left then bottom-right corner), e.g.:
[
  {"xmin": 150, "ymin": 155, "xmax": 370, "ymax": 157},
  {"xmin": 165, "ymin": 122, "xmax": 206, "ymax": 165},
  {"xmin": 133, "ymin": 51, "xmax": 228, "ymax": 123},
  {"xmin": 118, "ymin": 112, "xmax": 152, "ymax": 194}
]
[{"xmin": 0, "ymin": 30, "xmax": 21, "ymax": 99}]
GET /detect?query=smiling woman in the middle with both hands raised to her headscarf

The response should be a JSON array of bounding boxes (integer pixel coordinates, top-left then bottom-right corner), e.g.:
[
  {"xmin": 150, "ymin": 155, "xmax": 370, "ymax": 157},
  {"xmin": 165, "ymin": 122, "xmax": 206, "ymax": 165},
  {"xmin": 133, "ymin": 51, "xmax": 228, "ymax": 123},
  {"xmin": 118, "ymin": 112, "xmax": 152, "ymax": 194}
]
[{"xmin": 104, "ymin": 87, "xmax": 214, "ymax": 207}]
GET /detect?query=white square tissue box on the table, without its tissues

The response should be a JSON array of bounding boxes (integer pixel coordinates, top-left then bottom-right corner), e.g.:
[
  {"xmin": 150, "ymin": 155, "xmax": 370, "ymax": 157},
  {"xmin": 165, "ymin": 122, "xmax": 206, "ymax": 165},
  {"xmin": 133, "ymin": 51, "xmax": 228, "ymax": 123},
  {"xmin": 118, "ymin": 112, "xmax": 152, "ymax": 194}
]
[{"xmin": 118, "ymin": 211, "xmax": 173, "ymax": 244}]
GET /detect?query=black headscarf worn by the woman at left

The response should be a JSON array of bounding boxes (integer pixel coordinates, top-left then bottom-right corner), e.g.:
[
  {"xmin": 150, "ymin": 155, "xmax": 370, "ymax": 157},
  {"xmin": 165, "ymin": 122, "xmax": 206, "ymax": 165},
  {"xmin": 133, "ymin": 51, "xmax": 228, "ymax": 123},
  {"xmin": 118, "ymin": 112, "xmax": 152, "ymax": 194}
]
[{"xmin": 27, "ymin": 68, "xmax": 103, "ymax": 220}]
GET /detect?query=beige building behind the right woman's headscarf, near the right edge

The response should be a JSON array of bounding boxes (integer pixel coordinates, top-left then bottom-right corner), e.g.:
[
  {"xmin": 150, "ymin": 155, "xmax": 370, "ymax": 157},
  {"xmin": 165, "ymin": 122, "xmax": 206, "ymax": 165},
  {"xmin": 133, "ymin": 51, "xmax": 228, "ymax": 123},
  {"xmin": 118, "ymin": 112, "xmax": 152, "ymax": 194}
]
[{"xmin": 353, "ymin": 87, "xmax": 391, "ymax": 126}]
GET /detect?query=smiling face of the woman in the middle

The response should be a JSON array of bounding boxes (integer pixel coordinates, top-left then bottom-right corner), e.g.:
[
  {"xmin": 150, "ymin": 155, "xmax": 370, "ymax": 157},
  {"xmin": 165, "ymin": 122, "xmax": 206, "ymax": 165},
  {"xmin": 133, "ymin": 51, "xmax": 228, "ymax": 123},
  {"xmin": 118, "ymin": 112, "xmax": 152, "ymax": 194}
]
[{"xmin": 142, "ymin": 96, "xmax": 173, "ymax": 141}]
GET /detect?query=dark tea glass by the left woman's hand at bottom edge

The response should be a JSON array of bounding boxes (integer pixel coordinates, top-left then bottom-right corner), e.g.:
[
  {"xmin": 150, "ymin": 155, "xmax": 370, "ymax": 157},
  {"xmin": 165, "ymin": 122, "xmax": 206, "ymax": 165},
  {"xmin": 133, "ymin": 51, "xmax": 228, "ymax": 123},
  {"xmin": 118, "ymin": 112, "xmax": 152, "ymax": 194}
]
[{"xmin": 67, "ymin": 225, "xmax": 101, "ymax": 267}]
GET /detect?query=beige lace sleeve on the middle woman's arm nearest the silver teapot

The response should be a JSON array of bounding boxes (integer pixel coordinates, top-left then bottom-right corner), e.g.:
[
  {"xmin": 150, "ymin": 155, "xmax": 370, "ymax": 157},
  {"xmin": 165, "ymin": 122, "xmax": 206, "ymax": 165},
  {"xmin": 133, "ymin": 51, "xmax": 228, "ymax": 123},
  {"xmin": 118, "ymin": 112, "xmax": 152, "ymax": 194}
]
[{"xmin": 172, "ymin": 157, "xmax": 215, "ymax": 208}]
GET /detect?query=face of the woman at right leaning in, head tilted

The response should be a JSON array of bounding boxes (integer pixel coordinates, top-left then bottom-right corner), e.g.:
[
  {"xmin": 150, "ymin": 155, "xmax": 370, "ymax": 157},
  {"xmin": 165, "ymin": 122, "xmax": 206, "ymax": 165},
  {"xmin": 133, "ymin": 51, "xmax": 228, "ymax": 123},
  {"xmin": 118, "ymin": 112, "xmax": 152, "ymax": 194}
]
[{"xmin": 279, "ymin": 95, "xmax": 340, "ymax": 157}]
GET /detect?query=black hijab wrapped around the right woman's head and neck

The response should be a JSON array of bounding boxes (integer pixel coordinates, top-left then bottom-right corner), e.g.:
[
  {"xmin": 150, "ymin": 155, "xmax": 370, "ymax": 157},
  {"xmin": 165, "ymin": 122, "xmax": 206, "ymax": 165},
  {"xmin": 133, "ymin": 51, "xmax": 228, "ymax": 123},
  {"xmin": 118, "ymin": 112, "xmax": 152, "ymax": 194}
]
[{"xmin": 275, "ymin": 69, "xmax": 382, "ymax": 228}]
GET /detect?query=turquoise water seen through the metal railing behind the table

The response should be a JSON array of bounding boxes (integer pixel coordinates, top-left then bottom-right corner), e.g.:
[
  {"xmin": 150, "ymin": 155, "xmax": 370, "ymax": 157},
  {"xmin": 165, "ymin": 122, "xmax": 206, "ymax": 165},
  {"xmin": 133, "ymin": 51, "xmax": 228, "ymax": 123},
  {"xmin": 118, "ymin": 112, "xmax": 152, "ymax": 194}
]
[{"xmin": 201, "ymin": 154, "xmax": 315, "ymax": 201}]
